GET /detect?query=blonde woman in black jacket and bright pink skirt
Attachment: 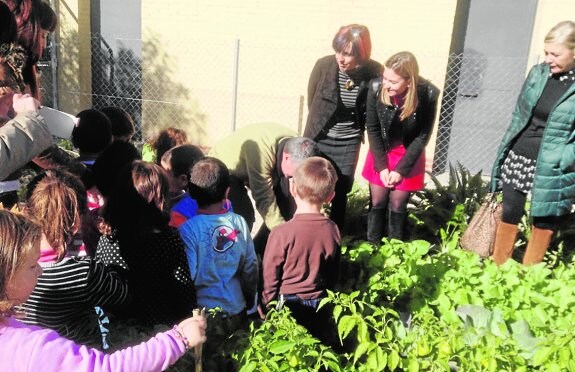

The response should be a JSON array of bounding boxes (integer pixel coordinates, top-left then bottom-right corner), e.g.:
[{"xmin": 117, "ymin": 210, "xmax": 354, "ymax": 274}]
[{"xmin": 362, "ymin": 52, "xmax": 439, "ymax": 244}]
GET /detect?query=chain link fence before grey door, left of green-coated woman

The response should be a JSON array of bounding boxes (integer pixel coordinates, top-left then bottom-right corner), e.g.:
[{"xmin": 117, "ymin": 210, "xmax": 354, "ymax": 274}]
[{"xmin": 433, "ymin": 53, "xmax": 526, "ymax": 175}]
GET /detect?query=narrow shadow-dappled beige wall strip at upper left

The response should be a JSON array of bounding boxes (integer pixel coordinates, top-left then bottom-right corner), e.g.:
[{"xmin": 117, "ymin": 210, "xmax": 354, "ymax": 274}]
[{"xmin": 52, "ymin": 0, "xmax": 92, "ymax": 114}]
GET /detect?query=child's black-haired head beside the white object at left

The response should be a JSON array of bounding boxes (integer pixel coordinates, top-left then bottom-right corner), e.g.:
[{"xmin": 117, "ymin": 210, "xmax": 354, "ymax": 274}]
[{"xmin": 72, "ymin": 109, "xmax": 112, "ymax": 154}]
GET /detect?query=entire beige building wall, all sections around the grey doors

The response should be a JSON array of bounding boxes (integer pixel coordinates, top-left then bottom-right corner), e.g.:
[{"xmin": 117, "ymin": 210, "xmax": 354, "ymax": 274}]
[{"xmin": 48, "ymin": 0, "xmax": 575, "ymax": 179}]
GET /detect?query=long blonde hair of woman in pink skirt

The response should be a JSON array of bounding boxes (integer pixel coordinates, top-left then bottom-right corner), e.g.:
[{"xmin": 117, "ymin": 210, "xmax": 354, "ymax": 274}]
[{"xmin": 381, "ymin": 52, "xmax": 419, "ymax": 121}]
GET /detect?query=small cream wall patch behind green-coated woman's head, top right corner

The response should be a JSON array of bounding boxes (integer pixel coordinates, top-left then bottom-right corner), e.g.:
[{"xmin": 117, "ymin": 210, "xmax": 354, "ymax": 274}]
[{"xmin": 527, "ymin": 0, "xmax": 575, "ymax": 67}]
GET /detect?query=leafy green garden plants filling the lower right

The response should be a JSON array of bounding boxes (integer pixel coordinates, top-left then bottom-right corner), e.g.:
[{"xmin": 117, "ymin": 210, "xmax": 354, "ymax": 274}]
[{"xmin": 110, "ymin": 161, "xmax": 575, "ymax": 371}]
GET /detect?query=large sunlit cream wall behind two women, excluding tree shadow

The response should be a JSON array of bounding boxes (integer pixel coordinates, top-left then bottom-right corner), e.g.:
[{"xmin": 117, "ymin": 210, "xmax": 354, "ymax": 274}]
[{"xmin": 142, "ymin": 0, "xmax": 456, "ymax": 150}]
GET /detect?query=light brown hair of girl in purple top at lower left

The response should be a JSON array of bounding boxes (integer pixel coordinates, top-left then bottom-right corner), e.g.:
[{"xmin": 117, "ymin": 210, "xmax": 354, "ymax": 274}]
[{"xmin": 0, "ymin": 209, "xmax": 42, "ymax": 321}]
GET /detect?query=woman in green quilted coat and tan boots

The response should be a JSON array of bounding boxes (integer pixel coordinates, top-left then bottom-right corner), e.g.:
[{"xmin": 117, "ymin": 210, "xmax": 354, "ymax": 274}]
[{"xmin": 491, "ymin": 21, "xmax": 575, "ymax": 265}]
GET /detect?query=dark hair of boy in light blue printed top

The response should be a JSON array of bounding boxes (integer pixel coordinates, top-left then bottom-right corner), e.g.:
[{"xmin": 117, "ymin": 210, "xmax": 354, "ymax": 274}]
[{"xmin": 189, "ymin": 157, "xmax": 230, "ymax": 208}]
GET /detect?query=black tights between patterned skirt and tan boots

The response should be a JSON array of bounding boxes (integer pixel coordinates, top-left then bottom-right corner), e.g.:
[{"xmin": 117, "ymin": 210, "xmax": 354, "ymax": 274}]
[{"xmin": 501, "ymin": 183, "xmax": 560, "ymax": 230}]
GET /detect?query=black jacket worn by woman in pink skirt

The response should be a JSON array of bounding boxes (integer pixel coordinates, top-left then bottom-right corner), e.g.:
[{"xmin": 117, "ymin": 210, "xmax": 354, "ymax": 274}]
[{"xmin": 366, "ymin": 79, "xmax": 439, "ymax": 177}]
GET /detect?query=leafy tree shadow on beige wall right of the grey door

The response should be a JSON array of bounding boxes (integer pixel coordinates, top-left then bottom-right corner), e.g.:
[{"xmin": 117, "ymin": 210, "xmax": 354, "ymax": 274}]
[{"xmin": 142, "ymin": 33, "xmax": 206, "ymax": 144}]
